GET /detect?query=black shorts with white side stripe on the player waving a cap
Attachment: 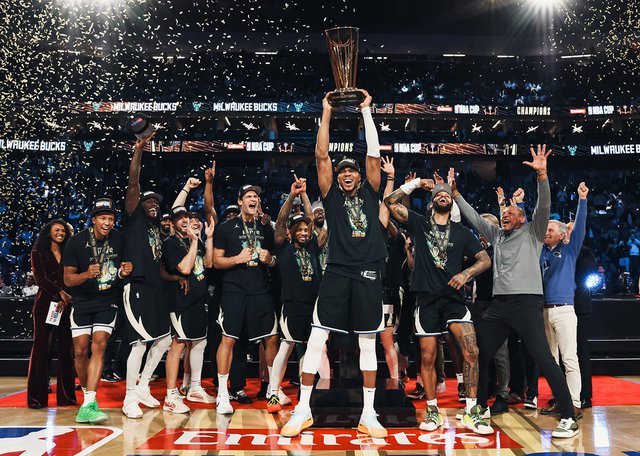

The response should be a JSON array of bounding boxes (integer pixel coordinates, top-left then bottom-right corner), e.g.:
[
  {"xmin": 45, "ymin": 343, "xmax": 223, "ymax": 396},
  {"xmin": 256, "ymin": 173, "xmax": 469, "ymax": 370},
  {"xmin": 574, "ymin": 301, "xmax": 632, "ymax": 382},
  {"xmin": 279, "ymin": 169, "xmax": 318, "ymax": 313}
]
[{"xmin": 122, "ymin": 282, "xmax": 171, "ymax": 342}]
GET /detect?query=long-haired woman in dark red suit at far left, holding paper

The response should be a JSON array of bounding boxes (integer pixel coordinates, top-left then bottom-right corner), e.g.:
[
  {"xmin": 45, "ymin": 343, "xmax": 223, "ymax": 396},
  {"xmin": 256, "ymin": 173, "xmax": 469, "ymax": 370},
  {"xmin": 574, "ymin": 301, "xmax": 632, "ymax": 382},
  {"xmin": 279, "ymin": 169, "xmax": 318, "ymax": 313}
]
[{"xmin": 27, "ymin": 220, "xmax": 76, "ymax": 408}]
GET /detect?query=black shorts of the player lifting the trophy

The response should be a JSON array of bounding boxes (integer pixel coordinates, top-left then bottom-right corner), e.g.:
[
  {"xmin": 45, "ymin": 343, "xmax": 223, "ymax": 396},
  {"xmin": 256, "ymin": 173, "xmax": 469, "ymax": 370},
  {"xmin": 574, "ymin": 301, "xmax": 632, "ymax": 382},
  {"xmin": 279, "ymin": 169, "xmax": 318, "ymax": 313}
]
[{"xmin": 312, "ymin": 270, "xmax": 384, "ymax": 334}]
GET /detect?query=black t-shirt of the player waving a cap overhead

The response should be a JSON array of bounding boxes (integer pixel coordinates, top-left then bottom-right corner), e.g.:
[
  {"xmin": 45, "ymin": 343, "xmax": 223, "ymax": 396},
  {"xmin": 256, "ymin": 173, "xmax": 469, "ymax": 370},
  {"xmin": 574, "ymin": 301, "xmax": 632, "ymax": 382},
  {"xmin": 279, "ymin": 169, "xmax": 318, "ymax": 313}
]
[{"xmin": 122, "ymin": 204, "xmax": 164, "ymax": 289}]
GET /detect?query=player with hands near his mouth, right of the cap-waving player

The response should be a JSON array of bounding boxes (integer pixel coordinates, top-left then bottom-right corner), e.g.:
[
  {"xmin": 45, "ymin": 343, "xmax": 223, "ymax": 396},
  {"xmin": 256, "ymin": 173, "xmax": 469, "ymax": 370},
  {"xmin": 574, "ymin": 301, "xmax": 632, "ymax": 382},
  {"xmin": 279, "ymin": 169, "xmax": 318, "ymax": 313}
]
[{"xmin": 162, "ymin": 206, "xmax": 215, "ymax": 413}]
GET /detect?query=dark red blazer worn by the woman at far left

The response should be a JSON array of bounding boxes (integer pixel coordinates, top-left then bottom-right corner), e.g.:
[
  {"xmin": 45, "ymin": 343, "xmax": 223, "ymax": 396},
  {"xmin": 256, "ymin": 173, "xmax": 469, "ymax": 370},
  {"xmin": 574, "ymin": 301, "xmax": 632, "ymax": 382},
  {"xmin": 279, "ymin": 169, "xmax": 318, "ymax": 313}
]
[{"xmin": 31, "ymin": 249, "xmax": 64, "ymax": 314}]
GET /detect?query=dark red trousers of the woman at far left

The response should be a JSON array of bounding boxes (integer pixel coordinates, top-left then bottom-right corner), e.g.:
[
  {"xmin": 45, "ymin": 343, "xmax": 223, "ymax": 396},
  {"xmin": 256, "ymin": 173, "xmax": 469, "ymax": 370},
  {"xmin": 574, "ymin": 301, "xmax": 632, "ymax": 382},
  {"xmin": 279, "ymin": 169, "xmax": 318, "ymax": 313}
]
[{"xmin": 27, "ymin": 306, "xmax": 76, "ymax": 408}]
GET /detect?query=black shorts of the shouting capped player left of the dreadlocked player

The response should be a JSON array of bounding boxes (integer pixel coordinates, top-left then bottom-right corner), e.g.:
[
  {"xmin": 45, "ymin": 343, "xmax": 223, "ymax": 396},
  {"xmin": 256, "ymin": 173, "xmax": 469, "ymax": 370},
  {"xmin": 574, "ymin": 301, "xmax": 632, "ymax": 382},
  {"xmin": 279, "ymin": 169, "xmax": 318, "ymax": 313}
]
[{"xmin": 218, "ymin": 291, "xmax": 278, "ymax": 342}]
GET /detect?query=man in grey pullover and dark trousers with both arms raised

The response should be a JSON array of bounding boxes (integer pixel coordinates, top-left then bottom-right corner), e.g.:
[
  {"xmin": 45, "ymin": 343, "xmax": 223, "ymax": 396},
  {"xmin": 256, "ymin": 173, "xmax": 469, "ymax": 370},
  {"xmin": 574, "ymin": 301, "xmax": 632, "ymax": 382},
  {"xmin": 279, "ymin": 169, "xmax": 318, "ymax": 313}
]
[{"xmin": 449, "ymin": 146, "xmax": 579, "ymax": 438}]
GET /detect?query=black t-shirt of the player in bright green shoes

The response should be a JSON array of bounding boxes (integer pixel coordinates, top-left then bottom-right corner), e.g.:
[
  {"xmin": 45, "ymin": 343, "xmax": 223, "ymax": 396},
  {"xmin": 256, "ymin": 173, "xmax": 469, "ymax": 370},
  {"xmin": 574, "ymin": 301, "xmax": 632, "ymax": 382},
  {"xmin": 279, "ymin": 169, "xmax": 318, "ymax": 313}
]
[{"xmin": 62, "ymin": 228, "xmax": 122, "ymax": 310}]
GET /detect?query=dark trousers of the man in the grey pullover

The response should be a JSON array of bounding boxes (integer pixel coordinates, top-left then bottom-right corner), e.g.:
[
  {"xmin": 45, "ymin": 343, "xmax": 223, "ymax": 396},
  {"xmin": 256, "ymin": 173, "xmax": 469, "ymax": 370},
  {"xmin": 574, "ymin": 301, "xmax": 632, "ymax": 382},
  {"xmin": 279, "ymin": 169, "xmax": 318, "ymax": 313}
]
[{"xmin": 477, "ymin": 295, "xmax": 574, "ymax": 418}]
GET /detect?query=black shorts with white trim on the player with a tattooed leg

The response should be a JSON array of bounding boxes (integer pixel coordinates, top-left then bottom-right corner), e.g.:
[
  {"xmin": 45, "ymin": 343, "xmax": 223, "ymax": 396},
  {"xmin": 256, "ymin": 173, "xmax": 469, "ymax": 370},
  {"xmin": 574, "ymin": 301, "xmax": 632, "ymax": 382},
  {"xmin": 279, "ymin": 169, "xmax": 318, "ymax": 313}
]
[{"xmin": 415, "ymin": 293, "xmax": 473, "ymax": 337}]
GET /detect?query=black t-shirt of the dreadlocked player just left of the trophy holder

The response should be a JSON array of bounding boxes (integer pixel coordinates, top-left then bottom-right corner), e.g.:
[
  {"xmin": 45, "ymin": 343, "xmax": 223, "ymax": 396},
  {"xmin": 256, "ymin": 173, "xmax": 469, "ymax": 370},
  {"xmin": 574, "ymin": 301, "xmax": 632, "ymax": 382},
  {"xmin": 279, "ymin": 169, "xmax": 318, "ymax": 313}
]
[{"xmin": 277, "ymin": 237, "xmax": 322, "ymax": 303}]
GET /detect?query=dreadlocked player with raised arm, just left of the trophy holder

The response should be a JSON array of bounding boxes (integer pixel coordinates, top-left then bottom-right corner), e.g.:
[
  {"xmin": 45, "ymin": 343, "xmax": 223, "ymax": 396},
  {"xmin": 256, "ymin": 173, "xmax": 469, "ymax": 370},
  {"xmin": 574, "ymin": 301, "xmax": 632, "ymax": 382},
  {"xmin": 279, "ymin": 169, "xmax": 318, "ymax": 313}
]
[{"xmin": 267, "ymin": 178, "xmax": 327, "ymax": 413}]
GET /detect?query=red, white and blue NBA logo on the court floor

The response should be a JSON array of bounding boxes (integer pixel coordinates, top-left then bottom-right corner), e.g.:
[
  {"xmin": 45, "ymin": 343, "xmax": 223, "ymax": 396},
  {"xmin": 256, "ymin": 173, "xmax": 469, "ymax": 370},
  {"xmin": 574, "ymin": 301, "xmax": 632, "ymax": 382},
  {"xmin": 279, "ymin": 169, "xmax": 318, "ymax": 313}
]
[{"xmin": 0, "ymin": 426, "xmax": 122, "ymax": 456}]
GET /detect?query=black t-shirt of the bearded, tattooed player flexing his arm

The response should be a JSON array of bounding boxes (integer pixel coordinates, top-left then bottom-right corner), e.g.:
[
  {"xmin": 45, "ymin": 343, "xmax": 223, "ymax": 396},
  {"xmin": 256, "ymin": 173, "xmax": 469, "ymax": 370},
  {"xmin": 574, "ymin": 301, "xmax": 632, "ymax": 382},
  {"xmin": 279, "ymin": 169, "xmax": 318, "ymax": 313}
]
[{"xmin": 407, "ymin": 211, "xmax": 482, "ymax": 301}]
